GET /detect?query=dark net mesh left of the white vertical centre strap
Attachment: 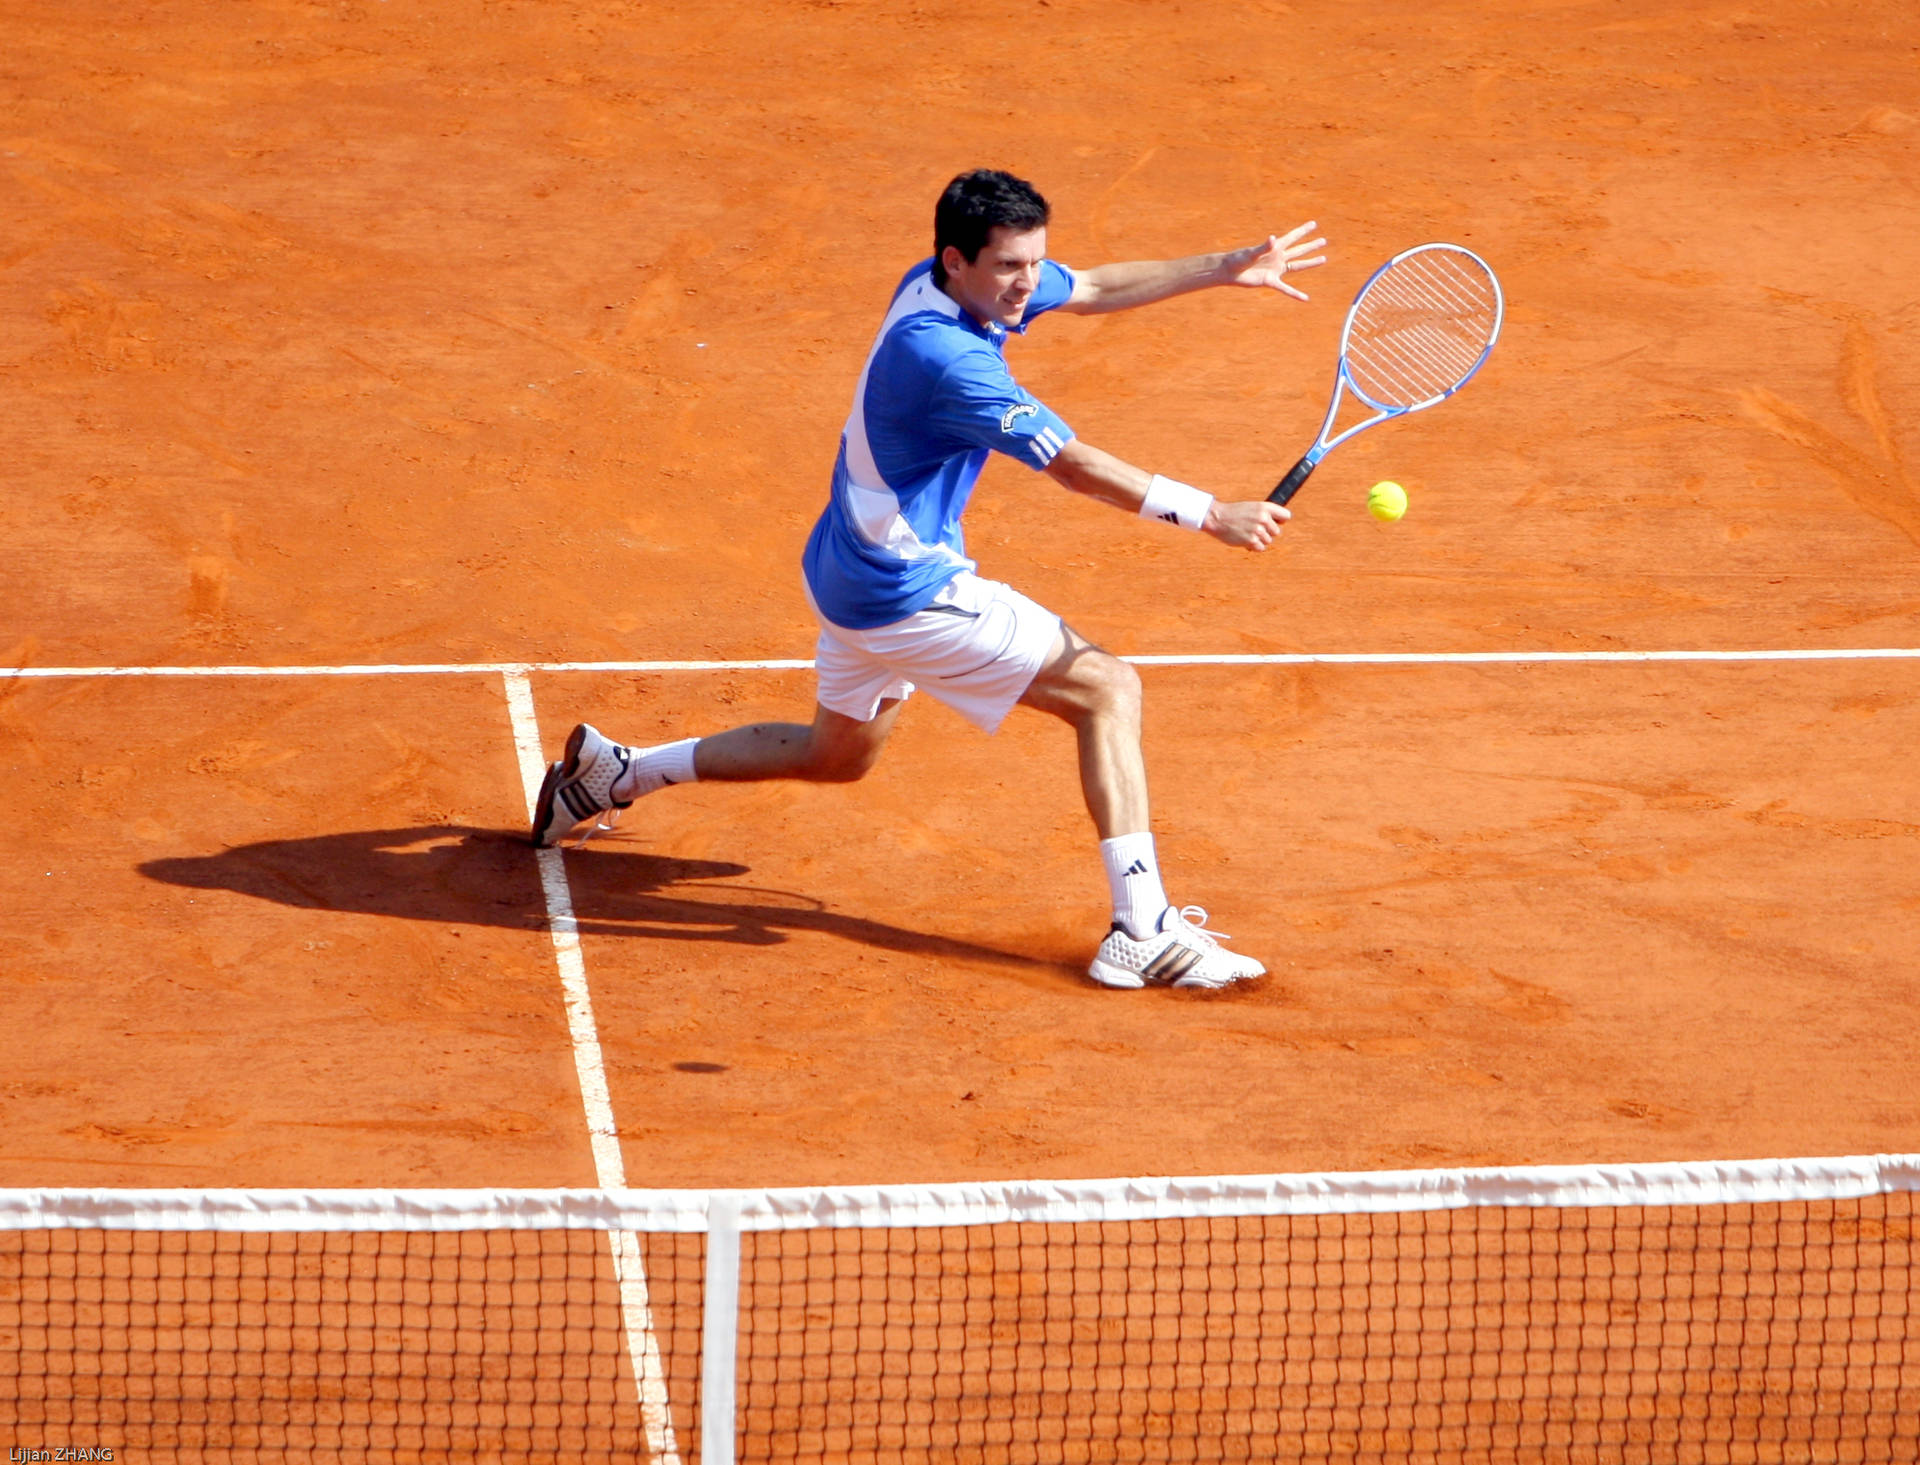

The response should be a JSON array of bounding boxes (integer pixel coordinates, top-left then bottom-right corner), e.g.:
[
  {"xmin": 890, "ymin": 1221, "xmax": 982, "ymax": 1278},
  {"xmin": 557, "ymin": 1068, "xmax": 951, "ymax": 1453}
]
[{"xmin": 0, "ymin": 1229, "xmax": 701, "ymax": 1465}]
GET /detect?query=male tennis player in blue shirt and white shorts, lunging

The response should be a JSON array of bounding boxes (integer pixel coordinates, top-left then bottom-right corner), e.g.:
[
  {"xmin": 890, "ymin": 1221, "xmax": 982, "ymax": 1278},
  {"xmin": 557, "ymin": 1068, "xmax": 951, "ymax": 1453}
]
[{"xmin": 534, "ymin": 169, "xmax": 1325, "ymax": 987}]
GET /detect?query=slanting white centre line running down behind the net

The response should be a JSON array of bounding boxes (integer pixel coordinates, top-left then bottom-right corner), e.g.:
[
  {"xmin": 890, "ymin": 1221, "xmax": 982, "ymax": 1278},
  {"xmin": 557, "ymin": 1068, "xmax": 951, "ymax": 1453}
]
[{"xmin": 501, "ymin": 670, "xmax": 680, "ymax": 1465}]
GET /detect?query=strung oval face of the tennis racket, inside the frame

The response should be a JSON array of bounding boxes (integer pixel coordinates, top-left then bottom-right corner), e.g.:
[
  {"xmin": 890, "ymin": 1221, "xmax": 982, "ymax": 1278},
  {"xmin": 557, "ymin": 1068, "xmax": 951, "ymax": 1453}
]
[{"xmin": 1346, "ymin": 250, "xmax": 1500, "ymax": 407}]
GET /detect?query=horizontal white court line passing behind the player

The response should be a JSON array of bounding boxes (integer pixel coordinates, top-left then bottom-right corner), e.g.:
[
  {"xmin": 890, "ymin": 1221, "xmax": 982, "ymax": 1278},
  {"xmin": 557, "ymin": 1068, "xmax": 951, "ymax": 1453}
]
[{"xmin": 11, "ymin": 647, "xmax": 1920, "ymax": 682}]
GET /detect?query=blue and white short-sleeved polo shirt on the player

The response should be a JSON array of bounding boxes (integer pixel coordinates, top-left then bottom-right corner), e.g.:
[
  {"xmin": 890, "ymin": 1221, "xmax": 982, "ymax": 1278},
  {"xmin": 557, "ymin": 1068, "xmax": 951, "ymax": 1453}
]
[{"xmin": 803, "ymin": 259, "xmax": 1073, "ymax": 630}]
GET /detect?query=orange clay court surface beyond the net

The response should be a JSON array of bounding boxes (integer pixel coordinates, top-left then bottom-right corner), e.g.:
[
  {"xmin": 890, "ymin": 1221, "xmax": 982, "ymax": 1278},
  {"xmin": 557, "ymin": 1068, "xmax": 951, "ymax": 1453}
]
[{"xmin": 0, "ymin": 0, "xmax": 1920, "ymax": 1236}]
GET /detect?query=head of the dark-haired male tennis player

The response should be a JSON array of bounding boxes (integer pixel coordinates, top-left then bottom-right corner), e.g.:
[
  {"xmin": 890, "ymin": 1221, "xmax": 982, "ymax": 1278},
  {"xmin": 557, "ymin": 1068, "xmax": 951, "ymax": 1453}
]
[{"xmin": 933, "ymin": 167, "xmax": 1052, "ymax": 326}]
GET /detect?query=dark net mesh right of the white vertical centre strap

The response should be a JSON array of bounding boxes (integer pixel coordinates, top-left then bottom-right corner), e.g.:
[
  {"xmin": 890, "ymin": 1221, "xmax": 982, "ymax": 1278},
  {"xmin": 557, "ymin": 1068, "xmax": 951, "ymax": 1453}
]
[{"xmin": 741, "ymin": 1196, "xmax": 1920, "ymax": 1465}]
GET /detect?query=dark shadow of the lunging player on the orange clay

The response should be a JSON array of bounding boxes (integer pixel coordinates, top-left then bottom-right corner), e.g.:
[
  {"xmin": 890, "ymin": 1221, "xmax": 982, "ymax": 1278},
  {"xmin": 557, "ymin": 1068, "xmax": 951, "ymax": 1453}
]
[{"xmin": 138, "ymin": 824, "xmax": 1062, "ymax": 972}]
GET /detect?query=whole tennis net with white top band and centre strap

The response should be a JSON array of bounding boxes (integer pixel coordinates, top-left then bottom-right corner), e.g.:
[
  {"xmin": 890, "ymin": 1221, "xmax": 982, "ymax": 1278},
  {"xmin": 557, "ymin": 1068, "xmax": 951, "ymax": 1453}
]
[{"xmin": 0, "ymin": 1156, "xmax": 1920, "ymax": 1465}]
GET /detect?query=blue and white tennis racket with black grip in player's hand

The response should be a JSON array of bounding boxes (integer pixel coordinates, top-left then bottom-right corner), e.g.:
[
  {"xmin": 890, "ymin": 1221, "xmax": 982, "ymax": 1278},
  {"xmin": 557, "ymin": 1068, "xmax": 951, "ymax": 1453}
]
[{"xmin": 1267, "ymin": 244, "xmax": 1505, "ymax": 503}]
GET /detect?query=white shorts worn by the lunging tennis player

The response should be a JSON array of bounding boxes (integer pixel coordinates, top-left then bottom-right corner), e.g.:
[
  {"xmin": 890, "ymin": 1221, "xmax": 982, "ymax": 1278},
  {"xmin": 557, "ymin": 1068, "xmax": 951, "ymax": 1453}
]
[{"xmin": 808, "ymin": 572, "xmax": 1060, "ymax": 733}]
